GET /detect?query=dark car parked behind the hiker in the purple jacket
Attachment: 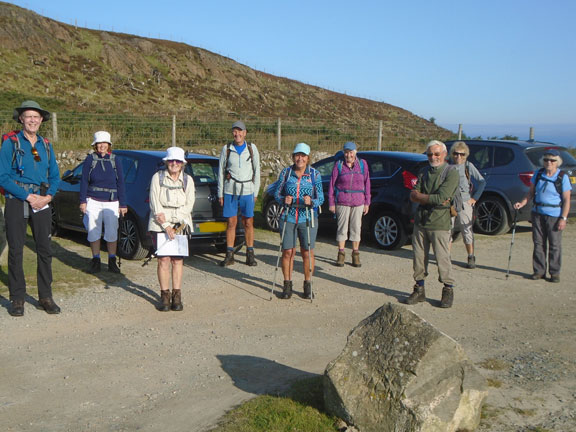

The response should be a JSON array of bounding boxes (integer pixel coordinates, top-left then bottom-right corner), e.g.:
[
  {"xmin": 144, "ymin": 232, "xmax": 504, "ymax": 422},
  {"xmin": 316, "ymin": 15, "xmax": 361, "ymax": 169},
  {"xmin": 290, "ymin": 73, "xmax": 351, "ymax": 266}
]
[{"xmin": 262, "ymin": 151, "xmax": 428, "ymax": 250}]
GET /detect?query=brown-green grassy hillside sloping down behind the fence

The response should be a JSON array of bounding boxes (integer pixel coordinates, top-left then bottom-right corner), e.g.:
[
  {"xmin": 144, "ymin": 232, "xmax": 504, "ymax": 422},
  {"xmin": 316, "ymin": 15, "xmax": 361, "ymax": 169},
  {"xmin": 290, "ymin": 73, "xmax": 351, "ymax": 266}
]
[{"xmin": 0, "ymin": 2, "xmax": 450, "ymax": 138}]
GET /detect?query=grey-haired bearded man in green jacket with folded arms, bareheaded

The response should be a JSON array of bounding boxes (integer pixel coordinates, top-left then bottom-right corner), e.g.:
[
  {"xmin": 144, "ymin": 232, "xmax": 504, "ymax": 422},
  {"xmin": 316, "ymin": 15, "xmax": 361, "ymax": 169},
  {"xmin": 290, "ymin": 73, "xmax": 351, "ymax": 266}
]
[{"xmin": 406, "ymin": 140, "xmax": 459, "ymax": 308}]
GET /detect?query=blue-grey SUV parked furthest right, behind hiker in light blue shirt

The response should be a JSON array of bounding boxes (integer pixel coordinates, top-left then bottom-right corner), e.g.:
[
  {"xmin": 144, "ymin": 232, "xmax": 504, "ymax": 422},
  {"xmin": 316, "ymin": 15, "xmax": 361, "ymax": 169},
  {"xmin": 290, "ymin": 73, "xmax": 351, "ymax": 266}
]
[{"xmin": 446, "ymin": 139, "xmax": 576, "ymax": 235}]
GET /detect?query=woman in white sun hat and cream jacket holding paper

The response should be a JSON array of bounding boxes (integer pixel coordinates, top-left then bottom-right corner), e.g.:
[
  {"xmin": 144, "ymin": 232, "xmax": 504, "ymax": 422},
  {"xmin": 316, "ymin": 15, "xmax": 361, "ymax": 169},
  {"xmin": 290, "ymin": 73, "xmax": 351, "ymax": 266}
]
[{"xmin": 148, "ymin": 147, "xmax": 195, "ymax": 312}]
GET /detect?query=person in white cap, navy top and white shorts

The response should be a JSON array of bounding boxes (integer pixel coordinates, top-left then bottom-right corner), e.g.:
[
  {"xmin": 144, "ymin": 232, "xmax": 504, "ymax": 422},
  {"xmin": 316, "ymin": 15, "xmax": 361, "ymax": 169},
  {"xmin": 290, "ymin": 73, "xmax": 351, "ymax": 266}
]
[{"xmin": 80, "ymin": 131, "xmax": 128, "ymax": 273}]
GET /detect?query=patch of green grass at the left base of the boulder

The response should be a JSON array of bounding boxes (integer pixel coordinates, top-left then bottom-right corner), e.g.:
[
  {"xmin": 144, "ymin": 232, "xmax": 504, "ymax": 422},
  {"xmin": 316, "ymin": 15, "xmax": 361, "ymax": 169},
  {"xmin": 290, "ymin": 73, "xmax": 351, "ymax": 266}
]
[{"xmin": 212, "ymin": 377, "xmax": 338, "ymax": 432}]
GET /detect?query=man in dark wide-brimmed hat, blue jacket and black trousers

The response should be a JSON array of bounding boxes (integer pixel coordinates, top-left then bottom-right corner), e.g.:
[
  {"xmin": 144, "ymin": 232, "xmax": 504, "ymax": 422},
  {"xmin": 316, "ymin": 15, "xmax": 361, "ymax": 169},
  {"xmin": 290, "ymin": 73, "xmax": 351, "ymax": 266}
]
[{"xmin": 0, "ymin": 100, "xmax": 60, "ymax": 316}]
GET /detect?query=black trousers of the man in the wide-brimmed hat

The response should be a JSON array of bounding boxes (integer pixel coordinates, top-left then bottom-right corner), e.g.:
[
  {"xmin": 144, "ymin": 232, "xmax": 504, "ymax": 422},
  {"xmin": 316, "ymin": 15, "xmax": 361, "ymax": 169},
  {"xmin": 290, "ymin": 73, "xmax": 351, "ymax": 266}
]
[{"xmin": 4, "ymin": 198, "xmax": 52, "ymax": 300}]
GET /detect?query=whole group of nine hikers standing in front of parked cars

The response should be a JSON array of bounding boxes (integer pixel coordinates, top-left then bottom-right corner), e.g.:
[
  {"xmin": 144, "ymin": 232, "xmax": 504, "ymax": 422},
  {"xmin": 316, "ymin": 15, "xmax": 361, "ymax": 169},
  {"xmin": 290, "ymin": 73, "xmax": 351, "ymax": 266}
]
[{"xmin": 0, "ymin": 101, "xmax": 571, "ymax": 316}]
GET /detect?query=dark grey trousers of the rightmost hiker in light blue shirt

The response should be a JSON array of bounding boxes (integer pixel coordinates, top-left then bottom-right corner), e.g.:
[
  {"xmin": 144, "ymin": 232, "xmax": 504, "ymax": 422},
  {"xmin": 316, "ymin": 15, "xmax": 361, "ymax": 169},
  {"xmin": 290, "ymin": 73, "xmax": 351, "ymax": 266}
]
[{"xmin": 532, "ymin": 212, "xmax": 562, "ymax": 276}]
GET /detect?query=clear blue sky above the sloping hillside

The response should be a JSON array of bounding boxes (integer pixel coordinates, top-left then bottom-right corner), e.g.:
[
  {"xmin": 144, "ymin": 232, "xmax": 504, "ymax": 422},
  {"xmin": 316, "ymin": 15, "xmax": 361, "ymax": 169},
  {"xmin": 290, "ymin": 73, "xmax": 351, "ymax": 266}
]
[{"xmin": 11, "ymin": 0, "xmax": 576, "ymax": 146}]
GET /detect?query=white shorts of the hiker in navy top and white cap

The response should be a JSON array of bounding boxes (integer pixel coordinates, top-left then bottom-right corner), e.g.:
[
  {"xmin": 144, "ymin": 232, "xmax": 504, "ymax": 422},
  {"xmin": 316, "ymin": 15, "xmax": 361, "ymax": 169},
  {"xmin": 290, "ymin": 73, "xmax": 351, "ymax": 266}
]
[{"xmin": 84, "ymin": 198, "xmax": 119, "ymax": 242}]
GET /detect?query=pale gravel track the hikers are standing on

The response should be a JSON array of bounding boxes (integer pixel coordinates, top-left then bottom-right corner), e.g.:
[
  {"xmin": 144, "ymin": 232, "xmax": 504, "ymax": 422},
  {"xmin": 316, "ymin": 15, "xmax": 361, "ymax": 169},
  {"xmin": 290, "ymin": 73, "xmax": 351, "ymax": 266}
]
[{"xmin": 0, "ymin": 225, "xmax": 576, "ymax": 432}]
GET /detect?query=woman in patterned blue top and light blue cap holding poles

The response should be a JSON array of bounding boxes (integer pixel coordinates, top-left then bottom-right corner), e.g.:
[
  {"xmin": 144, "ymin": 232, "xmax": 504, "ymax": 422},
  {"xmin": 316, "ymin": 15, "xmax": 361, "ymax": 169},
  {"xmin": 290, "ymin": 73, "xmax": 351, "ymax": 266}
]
[{"xmin": 274, "ymin": 143, "xmax": 324, "ymax": 299}]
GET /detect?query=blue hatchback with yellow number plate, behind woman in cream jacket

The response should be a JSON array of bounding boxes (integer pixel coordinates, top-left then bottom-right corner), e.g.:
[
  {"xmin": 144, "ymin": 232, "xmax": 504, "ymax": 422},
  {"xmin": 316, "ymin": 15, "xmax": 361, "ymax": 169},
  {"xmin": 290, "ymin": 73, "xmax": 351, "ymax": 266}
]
[{"xmin": 52, "ymin": 150, "xmax": 244, "ymax": 259}]
